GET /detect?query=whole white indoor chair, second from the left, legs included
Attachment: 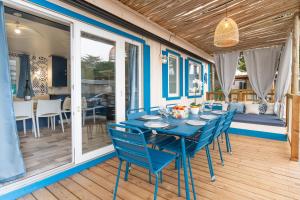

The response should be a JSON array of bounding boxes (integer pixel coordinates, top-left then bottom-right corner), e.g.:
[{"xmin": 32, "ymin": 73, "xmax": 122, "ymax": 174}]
[{"xmin": 36, "ymin": 99, "xmax": 65, "ymax": 137}]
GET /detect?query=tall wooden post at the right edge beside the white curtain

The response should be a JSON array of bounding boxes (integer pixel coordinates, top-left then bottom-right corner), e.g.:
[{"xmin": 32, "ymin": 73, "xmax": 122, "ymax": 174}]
[{"xmin": 290, "ymin": 13, "xmax": 300, "ymax": 161}]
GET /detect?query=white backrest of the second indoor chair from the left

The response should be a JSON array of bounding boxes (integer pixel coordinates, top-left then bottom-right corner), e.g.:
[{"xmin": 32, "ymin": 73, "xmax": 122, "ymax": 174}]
[{"xmin": 36, "ymin": 99, "xmax": 61, "ymax": 116}]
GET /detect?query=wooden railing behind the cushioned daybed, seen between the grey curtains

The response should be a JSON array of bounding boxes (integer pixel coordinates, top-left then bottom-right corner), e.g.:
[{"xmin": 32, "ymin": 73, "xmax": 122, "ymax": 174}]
[{"xmin": 206, "ymin": 90, "xmax": 274, "ymax": 103}]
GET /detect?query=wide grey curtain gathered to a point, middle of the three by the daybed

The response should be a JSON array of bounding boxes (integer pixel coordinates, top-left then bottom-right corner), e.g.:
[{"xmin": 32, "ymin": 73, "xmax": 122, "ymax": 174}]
[{"xmin": 243, "ymin": 47, "xmax": 280, "ymax": 102}]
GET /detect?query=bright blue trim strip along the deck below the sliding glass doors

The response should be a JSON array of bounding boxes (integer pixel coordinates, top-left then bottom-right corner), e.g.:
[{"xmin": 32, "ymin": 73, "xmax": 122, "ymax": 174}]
[{"xmin": 0, "ymin": 152, "xmax": 116, "ymax": 200}]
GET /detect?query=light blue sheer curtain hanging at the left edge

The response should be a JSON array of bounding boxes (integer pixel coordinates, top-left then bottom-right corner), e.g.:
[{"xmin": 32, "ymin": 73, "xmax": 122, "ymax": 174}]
[{"xmin": 0, "ymin": 1, "xmax": 25, "ymax": 183}]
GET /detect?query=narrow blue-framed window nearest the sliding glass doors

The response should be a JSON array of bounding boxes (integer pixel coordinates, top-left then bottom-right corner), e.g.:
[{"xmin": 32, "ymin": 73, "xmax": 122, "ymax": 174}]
[{"xmin": 162, "ymin": 49, "xmax": 183, "ymax": 100}]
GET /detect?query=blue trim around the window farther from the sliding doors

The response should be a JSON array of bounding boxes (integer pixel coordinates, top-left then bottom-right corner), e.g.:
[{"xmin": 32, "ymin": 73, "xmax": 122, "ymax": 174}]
[{"xmin": 185, "ymin": 57, "xmax": 204, "ymax": 99}]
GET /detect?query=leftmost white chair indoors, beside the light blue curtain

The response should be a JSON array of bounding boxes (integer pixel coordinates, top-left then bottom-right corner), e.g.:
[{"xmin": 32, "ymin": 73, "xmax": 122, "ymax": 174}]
[{"xmin": 14, "ymin": 101, "xmax": 37, "ymax": 137}]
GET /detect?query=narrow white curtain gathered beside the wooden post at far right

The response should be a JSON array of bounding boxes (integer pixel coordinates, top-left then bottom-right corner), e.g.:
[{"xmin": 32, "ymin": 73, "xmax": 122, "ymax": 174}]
[{"xmin": 275, "ymin": 34, "xmax": 292, "ymax": 118}]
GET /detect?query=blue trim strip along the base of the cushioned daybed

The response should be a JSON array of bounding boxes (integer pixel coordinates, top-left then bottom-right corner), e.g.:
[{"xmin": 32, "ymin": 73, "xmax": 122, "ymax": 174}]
[{"xmin": 228, "ymin": 128, "xmax": 287, "ymax": 141}]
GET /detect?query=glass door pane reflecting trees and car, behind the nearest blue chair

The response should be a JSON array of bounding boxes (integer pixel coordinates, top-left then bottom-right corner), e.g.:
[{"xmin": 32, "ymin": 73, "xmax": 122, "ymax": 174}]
[{"xmin": 81, "ymin": 32, "xmax": 116, "ymax": 153}]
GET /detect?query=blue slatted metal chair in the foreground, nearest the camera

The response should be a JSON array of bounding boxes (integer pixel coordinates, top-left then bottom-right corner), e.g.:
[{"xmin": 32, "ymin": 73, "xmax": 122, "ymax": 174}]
[{"xmin": 108, "ymin": 124, "xmax": 180, "ymax": 200}]
